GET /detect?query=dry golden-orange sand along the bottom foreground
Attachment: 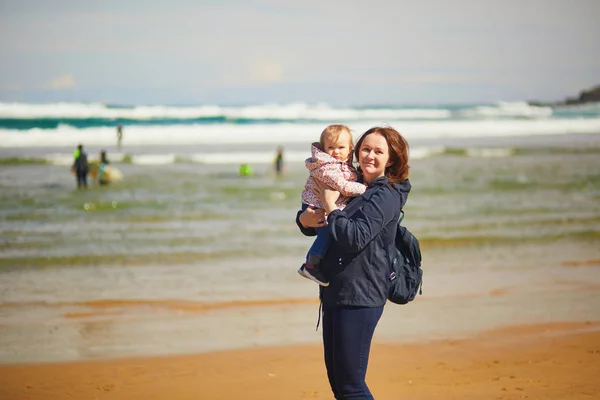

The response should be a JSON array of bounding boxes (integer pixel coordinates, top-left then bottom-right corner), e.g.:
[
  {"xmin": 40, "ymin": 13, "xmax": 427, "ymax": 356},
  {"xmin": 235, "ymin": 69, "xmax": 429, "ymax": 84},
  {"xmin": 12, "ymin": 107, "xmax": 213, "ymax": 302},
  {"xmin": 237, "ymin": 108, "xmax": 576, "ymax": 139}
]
[{"xmin": 0, "ymin": 322, "xmax": 600, "ymax": 400}]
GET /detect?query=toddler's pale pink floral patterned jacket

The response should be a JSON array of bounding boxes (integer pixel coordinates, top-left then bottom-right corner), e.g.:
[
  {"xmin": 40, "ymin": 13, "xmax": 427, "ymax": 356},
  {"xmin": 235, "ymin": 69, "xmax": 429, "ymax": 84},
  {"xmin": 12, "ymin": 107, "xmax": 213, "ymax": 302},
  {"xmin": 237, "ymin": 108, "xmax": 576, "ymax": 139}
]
[{"xmin": 302, "ymin": 143, "xmax": 367, "ymax": 209}]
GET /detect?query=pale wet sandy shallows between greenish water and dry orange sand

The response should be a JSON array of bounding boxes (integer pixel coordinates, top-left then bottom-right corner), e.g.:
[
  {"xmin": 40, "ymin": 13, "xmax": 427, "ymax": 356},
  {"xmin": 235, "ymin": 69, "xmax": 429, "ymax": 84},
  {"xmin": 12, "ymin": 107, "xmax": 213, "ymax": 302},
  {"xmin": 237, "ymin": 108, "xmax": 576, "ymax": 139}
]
[{"xmin": 0, "ymin": 242, "xmax": 600, "ymax": 365}]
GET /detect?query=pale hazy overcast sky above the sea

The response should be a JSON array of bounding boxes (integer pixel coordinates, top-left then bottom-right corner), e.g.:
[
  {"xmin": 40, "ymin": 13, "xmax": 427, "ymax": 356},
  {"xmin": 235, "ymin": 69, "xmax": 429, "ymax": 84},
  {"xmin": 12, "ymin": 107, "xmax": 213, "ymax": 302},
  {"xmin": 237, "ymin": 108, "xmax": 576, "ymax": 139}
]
[{"xmin": 0, "ymin": 0, "xmax": 600, "ymax": 105}]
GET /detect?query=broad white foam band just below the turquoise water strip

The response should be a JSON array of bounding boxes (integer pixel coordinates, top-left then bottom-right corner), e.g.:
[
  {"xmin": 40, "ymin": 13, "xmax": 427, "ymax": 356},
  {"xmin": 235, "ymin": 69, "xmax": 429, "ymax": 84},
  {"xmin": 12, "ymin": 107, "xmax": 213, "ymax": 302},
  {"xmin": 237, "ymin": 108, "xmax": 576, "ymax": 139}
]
[{"xmin": 0, "ymin": 118, "xmax": 600, "ymax": 148}]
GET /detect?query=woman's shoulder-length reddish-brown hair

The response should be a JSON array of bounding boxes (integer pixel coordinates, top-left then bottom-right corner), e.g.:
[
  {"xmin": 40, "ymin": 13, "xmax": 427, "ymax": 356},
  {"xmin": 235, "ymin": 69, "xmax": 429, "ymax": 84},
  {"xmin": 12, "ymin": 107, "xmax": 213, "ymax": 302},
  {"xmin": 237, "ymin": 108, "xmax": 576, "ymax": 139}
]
[{"xmin": 354, "ymin": 126, "xmax": 410, "ymax": 184}]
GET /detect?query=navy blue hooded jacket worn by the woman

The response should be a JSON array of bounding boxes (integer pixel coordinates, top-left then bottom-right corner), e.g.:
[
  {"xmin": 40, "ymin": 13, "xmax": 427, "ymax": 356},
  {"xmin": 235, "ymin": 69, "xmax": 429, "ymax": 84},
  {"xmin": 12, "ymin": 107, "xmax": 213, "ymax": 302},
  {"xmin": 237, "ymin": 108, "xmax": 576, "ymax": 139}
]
[{"xmin": 296, "ymin": 177, "xmax": 411, "ymax": 307}]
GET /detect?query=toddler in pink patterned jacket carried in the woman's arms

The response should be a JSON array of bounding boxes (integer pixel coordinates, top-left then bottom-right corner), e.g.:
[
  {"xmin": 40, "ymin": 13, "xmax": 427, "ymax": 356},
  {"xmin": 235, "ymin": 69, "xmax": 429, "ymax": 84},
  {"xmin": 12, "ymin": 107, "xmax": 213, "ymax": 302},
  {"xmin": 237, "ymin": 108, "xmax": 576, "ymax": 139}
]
[{"xmin": 298, "ymin": 125, "xmax": 367, "ymax": 286}]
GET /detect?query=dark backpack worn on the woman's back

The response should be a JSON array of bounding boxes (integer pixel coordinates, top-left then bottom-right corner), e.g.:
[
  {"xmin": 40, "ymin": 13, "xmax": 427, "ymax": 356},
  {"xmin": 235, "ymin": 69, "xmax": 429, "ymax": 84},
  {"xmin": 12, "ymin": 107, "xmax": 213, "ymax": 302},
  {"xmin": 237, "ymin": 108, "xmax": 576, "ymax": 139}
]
[{"xmin": 388, "ymin": 211, "xmax": 423, "ymax": 304}]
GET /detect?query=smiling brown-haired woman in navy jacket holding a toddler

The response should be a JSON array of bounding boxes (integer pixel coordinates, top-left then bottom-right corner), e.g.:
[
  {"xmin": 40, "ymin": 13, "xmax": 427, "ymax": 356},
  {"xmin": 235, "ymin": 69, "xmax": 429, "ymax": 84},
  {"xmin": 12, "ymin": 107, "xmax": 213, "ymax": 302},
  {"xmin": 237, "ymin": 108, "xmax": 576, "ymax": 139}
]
[{"xmin": 296, "ymin": 127, "xmax": 411, "ymax": 400}]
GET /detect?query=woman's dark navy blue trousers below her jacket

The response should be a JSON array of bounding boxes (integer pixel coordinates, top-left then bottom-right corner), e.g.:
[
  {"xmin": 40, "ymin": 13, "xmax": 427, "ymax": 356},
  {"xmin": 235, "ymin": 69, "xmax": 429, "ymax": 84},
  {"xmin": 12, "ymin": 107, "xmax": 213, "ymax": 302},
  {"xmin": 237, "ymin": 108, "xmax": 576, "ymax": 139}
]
[{"xmin": 323, "ymin": 307, "xmax": 383, "ymax": 400}]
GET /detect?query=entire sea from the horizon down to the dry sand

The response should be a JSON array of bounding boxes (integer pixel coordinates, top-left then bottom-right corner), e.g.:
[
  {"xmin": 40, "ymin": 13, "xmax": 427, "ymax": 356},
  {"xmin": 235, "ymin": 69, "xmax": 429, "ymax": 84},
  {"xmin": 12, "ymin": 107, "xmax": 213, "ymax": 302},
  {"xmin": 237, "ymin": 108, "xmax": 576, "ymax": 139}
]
[{"xmin": 0, "ymin": 103, "xmax": 600, "ymax": 362}]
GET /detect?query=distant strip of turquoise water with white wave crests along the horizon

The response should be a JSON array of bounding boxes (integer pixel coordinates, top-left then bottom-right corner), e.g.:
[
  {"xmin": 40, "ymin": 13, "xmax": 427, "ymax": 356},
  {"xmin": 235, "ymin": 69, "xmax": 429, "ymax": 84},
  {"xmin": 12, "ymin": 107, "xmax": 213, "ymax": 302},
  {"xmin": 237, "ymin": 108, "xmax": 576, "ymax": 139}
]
[{"xmin": 0, "ymin": 102, "xmax": 600, "ymax": 130}]
